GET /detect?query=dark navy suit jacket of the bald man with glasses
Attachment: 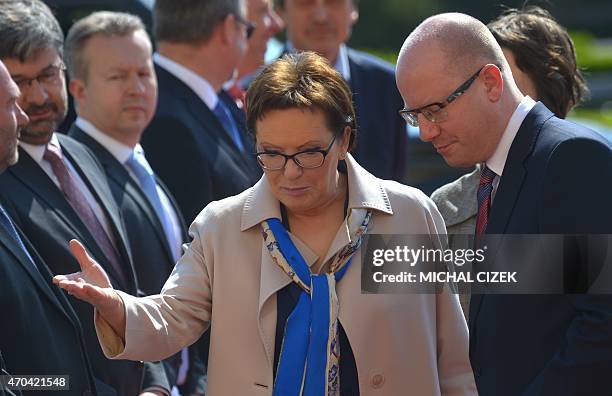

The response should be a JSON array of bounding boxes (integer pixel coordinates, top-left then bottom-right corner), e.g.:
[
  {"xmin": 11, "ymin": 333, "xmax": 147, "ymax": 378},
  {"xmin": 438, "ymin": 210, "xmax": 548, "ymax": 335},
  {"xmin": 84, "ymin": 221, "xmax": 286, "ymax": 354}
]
[{"xmin": 469, "ymin": 103, "xmax": 612, "ymax": 396}]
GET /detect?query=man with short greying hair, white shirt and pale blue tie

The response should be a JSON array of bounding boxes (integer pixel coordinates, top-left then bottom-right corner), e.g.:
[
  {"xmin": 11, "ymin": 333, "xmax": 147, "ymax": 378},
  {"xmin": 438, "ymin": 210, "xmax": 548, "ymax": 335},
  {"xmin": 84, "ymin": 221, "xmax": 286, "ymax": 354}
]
[{"xmin": 65, "ymin": 11, "xmax": 189, "ymax": 391}]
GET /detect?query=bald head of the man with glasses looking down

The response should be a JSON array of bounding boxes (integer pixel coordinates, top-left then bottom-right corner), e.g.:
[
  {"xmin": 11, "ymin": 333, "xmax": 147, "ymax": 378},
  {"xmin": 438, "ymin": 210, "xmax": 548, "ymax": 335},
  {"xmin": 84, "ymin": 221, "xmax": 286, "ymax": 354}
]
[{"xmin": 396, "ymin": 13, "xmax": 522, "ymax": 166}]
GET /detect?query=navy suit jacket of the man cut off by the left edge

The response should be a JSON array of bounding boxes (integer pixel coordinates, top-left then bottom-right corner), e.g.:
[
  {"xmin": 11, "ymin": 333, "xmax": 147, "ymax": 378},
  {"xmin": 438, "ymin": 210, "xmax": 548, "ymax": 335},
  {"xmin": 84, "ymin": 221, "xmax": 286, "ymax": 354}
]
[{"xmin": 0, "ymin": 224, "xmax": 95, "ymax": 396}]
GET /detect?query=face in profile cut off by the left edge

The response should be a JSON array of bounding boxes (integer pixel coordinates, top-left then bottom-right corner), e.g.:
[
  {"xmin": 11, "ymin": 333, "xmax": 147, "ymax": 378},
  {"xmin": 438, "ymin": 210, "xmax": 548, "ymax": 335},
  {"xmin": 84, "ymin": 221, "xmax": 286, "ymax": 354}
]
[{"xmin": 0, "ymin": 64, "xmax": 28, "ymax": 172}]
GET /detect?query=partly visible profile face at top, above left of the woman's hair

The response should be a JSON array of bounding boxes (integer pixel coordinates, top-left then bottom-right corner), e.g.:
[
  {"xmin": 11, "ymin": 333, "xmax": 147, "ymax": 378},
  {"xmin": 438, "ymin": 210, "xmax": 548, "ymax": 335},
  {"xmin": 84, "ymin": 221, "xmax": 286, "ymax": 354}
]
[{"xmin": 238, "ymin": 0, "xmax": 283, "ymax": 77}]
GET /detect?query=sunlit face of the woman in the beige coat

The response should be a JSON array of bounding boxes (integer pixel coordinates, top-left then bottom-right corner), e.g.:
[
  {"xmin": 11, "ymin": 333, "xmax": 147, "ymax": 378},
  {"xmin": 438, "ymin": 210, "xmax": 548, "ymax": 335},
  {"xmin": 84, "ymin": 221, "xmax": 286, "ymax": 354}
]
[{"xmin": 255, "ymin": 109, "xmax": 348, "ymax": 213}]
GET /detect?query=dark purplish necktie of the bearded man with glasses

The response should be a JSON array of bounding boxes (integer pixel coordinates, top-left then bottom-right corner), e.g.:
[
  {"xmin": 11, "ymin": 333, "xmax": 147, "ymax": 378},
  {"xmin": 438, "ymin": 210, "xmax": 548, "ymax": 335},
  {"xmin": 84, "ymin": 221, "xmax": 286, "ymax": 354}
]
[{"xmin": 43, "ymin": 143, "xmax": 129, "ymax": 285}]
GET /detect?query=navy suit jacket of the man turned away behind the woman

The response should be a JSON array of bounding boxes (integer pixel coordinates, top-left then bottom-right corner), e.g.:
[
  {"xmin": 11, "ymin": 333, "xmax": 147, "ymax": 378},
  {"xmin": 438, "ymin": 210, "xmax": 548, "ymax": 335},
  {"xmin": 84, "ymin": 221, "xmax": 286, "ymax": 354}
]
[{"xmin": 141, "ymin": 66, "xmax": 261, "ymax": 224}]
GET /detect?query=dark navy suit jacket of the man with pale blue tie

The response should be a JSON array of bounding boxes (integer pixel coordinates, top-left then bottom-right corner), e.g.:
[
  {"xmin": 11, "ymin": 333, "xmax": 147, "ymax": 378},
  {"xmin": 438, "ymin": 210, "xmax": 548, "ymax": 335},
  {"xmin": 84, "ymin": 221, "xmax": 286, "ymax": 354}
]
[{"xmin": 68, "ymin": 125, "xmax": 187, "ymax": 389}]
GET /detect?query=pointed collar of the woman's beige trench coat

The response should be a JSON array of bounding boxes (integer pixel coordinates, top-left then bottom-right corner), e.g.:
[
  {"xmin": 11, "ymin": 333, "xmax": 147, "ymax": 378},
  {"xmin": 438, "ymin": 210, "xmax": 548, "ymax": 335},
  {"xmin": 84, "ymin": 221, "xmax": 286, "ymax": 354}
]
[{"xmin": 240, "ymin": 154, "xmax": 393, "ymax": 231}]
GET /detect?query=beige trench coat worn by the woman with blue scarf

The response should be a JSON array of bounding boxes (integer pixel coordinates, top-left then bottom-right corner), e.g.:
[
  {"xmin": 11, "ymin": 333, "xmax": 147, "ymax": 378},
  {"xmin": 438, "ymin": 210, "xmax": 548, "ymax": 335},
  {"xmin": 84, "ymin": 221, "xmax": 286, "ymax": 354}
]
[{"xmin": 96, "ymin": 156, "xmax": 476, "ymax": 396}]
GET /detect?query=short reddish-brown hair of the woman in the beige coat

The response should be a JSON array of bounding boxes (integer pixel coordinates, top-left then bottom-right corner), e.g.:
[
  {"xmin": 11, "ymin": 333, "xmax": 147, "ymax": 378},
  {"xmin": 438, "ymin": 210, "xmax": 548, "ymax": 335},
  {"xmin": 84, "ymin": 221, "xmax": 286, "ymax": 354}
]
[{"xmin": 246, "ymin": 52, "xmax": 357, "ymax": 150}]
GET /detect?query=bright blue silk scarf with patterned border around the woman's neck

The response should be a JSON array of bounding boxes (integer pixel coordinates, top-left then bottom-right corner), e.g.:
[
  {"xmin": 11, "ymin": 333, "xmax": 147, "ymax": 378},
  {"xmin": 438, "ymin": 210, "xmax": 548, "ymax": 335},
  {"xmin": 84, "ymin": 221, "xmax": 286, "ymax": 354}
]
[{"xmin": 261, "ymin": 209, "xmax": 372, "ymax": 396}]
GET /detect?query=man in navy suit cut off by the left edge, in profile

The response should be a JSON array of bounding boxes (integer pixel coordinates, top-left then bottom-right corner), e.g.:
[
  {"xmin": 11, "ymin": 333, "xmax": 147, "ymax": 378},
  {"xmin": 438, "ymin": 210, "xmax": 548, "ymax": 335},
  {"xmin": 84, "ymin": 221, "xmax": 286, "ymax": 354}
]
[{"xmin": 0, "ymin": 61, "xmax": 97, "ymax": 396}]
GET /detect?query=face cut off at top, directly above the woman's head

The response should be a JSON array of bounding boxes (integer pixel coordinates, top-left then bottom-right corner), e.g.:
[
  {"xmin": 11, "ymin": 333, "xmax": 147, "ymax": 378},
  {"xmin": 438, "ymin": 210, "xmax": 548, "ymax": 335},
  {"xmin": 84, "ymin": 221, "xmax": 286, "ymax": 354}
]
[{"xmin": 279, "ymin": 0, "xmax": 359, "ymax": 63}]
